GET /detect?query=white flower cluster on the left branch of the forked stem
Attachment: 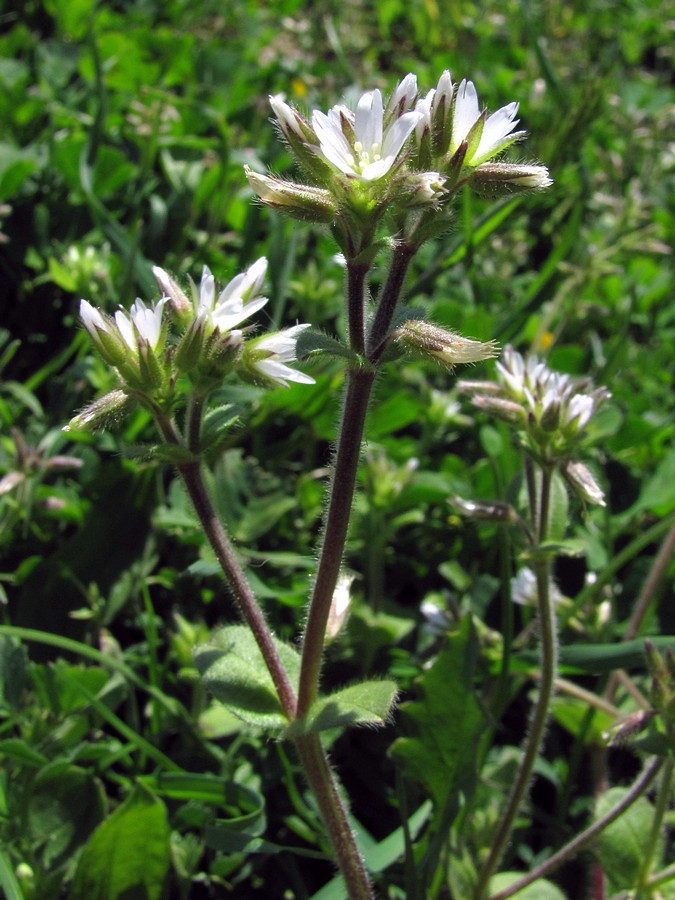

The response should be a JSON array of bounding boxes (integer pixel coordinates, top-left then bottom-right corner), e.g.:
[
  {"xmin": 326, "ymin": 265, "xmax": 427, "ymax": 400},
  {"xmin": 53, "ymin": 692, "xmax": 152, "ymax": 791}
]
[{"xmin": 68, "ymin": 258, "xmax": 314, "ymax": 430}]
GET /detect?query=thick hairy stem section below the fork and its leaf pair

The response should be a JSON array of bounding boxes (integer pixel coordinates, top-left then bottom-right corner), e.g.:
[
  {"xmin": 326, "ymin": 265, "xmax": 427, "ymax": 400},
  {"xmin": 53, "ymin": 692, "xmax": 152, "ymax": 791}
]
[{"xmin": 295, "ymin": 734, "xmax": 374, "ymax": 900}]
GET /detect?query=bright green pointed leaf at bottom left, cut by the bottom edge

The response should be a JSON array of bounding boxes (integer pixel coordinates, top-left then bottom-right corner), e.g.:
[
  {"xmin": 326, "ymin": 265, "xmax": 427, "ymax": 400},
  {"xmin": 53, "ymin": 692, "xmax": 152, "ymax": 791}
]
[{"xmin": 69, "ymin": 785, "xmax": 171, "ymax": 900}]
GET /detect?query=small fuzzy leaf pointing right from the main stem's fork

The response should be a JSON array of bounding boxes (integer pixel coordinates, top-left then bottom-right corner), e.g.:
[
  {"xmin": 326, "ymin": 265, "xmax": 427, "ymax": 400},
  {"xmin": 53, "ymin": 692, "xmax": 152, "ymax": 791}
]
[{"xmin": 286, "ymin": 681, "xmax": 398, "ymax": 737}]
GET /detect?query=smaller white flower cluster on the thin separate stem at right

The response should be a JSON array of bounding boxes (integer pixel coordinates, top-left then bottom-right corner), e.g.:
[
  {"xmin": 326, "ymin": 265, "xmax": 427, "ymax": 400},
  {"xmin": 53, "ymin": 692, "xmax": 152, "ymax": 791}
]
[{"xmin": 459, "ymin": 347, "xmax": 611, "ymax": 505}]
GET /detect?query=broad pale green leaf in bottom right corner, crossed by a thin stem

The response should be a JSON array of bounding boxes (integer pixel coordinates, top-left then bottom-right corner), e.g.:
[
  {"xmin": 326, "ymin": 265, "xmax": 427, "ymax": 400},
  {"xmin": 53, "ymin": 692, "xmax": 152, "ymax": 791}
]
[{"xmin": 595, "ymin": 787, "xmax": 663, "ymax": 891}]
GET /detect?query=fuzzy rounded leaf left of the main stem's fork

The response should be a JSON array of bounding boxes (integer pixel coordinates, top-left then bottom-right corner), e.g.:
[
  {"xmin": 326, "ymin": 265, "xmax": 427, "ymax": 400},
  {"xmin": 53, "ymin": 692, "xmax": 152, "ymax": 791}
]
[{"xmin": 195, "ymin": 625, "xmax": 300, "ymax": 730}]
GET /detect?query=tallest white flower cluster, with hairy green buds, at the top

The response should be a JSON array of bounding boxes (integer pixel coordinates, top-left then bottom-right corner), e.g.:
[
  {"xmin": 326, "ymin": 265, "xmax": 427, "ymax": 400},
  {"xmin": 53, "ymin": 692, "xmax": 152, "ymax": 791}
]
[{"xmin": 246, "ymin": 71, "xmax": 551, "ymax": 234}]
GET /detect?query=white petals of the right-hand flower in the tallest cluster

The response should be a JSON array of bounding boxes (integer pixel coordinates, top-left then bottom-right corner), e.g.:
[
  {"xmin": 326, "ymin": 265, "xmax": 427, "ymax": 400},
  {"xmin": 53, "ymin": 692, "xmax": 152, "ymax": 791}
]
[{"xmin": 450, "ymin": 78, "xmax": 525, "ymax": 166}]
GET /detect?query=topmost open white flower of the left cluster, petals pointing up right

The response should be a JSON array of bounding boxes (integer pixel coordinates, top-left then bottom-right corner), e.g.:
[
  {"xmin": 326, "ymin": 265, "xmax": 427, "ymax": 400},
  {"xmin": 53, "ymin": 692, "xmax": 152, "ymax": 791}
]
[{"xmin": 195, "ymin": 256, "xmax": 267, "ymax": 332}]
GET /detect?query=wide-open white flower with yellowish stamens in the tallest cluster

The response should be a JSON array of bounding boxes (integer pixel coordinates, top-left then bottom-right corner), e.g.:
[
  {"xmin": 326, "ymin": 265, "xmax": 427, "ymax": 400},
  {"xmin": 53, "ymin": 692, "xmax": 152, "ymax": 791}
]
[{"xmin": 312, "ymin": 90, "xmax": 421, "ymax": 181}]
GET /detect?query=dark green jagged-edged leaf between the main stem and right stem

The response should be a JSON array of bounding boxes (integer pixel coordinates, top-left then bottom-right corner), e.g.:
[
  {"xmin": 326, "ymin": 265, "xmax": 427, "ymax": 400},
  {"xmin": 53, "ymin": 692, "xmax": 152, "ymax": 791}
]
[{"xmin": 391, "ymin": 616, "xmax": 485, "ymax": 808}]
